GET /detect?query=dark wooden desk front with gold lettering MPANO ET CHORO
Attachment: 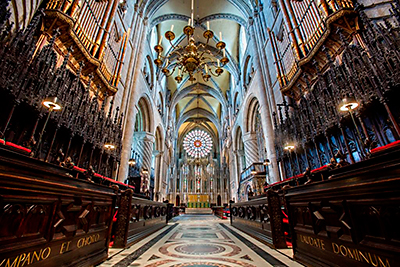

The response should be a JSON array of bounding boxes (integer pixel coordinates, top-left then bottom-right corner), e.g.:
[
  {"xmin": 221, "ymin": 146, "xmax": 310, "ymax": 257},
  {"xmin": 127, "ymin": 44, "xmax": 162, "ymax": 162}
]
[{"xmin": 0, "ymin": 148, "xmax": 116, "ymax": 266}]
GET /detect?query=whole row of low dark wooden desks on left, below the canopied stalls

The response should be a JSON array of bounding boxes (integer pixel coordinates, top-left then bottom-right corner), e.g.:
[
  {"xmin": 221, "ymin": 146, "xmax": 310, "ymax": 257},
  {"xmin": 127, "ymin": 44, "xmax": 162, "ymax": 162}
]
[{"xmin": 0, "ymin": 146, "xmax": 168, "ymax": 266}]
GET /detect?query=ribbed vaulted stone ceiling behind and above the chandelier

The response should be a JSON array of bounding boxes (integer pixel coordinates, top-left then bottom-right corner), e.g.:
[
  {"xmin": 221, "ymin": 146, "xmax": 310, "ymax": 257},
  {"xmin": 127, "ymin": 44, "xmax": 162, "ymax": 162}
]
[{"xmin": 149, "ymin": 0, "xmax": 250, "ymax": 144}]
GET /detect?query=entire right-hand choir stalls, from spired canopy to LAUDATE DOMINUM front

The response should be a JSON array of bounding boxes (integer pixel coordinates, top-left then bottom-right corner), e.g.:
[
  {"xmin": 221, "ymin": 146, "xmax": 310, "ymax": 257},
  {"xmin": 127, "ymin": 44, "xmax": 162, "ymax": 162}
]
[{"xmin": 231, "ymin": 1, "xmax": 400, "ymax": 267}]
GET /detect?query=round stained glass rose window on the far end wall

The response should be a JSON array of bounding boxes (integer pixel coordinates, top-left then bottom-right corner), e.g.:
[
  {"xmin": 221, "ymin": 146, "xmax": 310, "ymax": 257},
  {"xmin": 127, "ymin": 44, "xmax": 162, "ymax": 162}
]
[{"xmin": 183, "ymin": 130, "xmax": 212, "ymax": 158}]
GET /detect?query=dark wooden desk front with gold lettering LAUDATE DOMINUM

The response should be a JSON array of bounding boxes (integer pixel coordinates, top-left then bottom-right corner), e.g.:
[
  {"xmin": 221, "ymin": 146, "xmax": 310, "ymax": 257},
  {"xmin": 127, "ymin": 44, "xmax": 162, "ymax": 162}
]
[{"xmin": 286, "ymin": 146, "xmax": 400, "ymax": 267}]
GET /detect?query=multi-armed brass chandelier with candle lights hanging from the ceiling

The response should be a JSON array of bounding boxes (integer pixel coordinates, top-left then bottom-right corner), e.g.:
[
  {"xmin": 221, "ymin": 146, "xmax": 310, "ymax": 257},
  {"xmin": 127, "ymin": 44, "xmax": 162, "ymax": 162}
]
[{"xmin": 154, "ymin": 0, "xmax": 229, "ymax": 83}]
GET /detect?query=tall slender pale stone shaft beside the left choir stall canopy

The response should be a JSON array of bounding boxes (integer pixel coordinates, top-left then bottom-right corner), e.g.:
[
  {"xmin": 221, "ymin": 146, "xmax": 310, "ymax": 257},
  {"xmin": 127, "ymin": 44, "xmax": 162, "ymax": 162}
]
[{"xmin": 118, "ymin": 19, "xmax": 147, "ymax": 182}]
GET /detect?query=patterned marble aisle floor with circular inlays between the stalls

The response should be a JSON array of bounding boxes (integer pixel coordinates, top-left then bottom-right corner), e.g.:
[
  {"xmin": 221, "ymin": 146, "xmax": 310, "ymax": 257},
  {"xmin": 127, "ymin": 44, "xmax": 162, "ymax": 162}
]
[{"xmin": 98, "ymin": 215, "xmax": 302, "ymax": 267}]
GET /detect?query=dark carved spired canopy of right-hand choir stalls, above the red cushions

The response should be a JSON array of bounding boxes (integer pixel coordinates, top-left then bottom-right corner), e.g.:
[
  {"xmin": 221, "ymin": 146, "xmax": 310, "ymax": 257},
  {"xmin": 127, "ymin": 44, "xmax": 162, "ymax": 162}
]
[{"xmin": 273, "ymin": 1, "xmax": 400, "ymax": 178}]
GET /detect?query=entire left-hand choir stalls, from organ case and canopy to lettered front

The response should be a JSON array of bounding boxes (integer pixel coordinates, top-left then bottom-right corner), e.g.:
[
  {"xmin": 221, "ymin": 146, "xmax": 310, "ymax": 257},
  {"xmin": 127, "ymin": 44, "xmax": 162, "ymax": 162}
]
[{"xmin": 0, "ymin": 1, "xmax": 167, "ymax": 266}]
